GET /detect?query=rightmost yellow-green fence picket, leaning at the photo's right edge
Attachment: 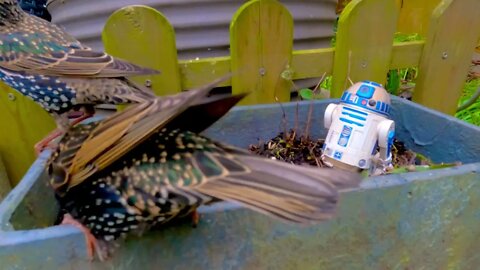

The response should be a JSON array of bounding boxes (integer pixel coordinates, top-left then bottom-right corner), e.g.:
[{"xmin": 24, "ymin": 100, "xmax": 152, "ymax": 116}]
[{"xmin": 413, "ymin": 0, "xmax": 480, "ymax": 115}]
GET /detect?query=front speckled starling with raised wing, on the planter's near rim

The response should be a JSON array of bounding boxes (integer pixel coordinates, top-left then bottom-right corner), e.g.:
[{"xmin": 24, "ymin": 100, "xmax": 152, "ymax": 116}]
[{"xmin": 48, "ymin": 83, "xmax": 360, "ymax": 258}]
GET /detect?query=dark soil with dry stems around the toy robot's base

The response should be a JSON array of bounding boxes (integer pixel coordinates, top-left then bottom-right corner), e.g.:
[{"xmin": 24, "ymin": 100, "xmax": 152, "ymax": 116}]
[{"xmin": 249, "ymin": 129, "xmax": 460, "ymax": 173}]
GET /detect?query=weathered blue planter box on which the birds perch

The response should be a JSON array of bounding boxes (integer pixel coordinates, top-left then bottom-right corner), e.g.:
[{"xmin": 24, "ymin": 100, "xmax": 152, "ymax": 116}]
[{"xmin": 0, "ymin": 97, "xmax": 480, "ymax": 269}]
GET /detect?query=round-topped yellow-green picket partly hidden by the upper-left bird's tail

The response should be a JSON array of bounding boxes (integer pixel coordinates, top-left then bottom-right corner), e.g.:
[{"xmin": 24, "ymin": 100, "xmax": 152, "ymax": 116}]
[{"xmin": 102, "ymin": 6, "xmax": 181, "ymax": 95}]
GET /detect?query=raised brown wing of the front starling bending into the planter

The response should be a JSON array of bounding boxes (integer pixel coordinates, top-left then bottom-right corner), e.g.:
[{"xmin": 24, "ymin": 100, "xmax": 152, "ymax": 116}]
[{"xmin": 57, "ymin": 75, "xmax": 234, "ymax": 190}]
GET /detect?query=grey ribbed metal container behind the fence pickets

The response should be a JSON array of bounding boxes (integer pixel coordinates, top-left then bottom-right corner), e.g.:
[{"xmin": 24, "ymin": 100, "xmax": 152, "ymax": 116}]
[{"xmin": 47, "ymin": 0, "xmax": 337, "ymax": 59}]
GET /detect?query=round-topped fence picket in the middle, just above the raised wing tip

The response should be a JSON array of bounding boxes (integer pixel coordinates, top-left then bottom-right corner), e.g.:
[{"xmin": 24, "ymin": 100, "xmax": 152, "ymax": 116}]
[{"xmin": 230, "ymin": 0, "xmax": 293, "ymax": 105}]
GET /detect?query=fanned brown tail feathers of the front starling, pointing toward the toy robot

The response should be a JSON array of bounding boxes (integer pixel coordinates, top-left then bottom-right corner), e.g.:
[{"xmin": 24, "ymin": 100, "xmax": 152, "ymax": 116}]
[{"xmin": 195, "ymin": 155, "xmax": 361, "ymax": 224}]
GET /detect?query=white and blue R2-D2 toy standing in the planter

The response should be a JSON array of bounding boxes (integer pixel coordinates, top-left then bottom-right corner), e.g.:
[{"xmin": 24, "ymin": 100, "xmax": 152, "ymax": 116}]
[{"xmin": 322, "ymin": 81, "xmax": 395, "ymax": 172}]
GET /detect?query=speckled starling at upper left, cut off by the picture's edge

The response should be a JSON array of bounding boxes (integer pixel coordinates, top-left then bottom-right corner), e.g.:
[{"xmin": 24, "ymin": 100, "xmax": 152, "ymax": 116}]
[{"xmin": 0, "ymin": 0, "xmax": 159, "ymax": 152}]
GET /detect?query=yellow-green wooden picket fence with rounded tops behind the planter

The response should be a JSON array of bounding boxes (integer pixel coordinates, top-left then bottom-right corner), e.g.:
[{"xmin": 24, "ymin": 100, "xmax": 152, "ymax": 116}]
[{"xmin": 0, "ymin": 0, "xmax": 480, "ymax": 183}]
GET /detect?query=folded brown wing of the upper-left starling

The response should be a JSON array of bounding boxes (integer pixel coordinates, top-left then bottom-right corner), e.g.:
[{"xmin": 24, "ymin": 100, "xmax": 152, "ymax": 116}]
[{"xmin": 0, "ymin": 14, "xmax": 159, "ymax": 77}]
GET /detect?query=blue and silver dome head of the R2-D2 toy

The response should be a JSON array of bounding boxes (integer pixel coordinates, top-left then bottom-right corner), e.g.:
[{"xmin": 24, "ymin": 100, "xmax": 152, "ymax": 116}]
[{"xmin": 341, "ymin": 81, "xmax": 391, "ymax": 116}]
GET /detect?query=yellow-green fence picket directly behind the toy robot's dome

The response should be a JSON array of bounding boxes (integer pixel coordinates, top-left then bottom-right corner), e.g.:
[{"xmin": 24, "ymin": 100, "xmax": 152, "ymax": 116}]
[{"xmin": 331, "ymin": 0, "xmax": 399, "ymax": 97}]
